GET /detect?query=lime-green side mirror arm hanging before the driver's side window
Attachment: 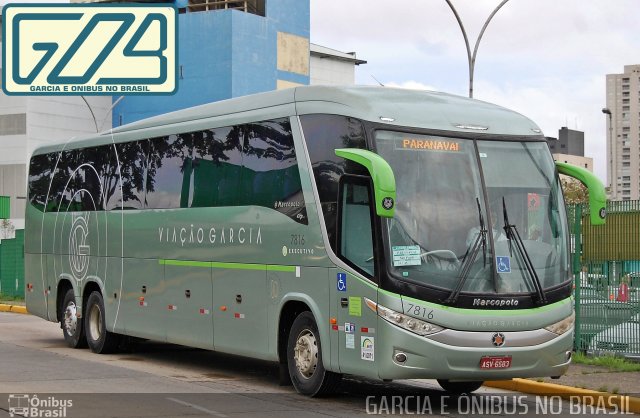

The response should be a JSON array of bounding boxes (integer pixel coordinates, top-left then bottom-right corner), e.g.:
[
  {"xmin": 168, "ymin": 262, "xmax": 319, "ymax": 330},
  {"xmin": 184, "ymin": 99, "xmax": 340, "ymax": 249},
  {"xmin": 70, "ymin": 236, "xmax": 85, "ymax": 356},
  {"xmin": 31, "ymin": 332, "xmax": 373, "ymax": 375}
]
[{"xmin": 335, "ymin": 148, "xmax": 396, "ymax": 218}]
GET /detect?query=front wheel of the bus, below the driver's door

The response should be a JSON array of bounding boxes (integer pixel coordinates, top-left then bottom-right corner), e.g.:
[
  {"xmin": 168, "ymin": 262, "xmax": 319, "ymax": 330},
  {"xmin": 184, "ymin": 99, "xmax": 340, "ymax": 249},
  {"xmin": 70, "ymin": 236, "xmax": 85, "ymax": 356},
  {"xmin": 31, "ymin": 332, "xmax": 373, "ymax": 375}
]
[{"xmin": 287, "ymin": 311, "xmax": 342, "ymax": 396}]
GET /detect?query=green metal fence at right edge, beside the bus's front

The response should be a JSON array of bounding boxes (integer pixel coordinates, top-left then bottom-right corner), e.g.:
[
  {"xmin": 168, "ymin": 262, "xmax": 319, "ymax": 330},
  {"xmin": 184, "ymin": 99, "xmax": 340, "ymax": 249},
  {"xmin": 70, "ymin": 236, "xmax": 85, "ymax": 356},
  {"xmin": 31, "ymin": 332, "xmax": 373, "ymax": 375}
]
[{"xmin": 568, "ymin": 201, "xmax": 640, "ymax": 358}]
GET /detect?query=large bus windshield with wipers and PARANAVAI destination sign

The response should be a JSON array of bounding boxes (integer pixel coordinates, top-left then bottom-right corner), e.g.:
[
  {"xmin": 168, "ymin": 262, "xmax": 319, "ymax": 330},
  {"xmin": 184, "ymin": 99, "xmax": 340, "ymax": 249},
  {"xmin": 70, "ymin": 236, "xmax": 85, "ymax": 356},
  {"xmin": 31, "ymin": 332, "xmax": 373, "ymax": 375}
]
[{"xmin": 375, "ymin": 131, "xmax": 569, "ymax": 296}]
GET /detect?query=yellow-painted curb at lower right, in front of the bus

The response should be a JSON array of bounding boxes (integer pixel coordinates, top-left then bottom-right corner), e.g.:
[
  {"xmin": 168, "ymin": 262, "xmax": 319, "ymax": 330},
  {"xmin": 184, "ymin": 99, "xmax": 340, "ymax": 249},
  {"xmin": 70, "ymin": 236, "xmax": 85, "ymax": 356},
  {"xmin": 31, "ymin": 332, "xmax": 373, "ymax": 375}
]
[{"xmin": 484, "ymin": 379, "xmax": 640, "ymax": 414}]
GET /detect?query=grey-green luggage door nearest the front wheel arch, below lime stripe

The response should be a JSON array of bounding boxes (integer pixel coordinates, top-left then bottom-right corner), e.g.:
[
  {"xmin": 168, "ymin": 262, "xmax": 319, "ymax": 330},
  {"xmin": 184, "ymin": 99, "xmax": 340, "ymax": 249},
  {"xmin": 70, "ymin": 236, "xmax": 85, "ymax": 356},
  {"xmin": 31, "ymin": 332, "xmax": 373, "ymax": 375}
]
[{"xmin": 213, "ymin": 264, "xmax": 269, "ymax": 359}]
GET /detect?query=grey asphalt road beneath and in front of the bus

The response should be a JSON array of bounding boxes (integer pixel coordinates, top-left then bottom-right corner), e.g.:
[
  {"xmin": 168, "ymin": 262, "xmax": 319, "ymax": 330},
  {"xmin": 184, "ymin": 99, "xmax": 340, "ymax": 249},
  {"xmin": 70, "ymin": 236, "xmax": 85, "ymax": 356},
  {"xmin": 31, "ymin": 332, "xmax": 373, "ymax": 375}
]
[{"xmin": 0, "ymin": 313, "xmax": 624, "ymax": 418}]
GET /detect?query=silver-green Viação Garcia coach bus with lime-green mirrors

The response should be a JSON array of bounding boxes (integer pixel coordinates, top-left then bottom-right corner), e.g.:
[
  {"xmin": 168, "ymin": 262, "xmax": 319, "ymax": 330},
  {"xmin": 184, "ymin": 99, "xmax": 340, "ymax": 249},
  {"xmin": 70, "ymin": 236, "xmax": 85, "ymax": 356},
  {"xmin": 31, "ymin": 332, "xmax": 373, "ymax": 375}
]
[{"xmin": 25, "ymin": 87, "xmax": 605, "ymax": 395}]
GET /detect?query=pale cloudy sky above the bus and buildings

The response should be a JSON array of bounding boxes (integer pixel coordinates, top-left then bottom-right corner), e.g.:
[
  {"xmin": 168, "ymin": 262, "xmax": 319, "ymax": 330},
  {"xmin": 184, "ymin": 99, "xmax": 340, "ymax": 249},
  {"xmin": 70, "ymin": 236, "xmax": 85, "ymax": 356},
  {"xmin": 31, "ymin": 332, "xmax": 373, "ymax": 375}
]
[{"xmin": 311, "ymin": 0, "xmax": 640, "ymax": 181}]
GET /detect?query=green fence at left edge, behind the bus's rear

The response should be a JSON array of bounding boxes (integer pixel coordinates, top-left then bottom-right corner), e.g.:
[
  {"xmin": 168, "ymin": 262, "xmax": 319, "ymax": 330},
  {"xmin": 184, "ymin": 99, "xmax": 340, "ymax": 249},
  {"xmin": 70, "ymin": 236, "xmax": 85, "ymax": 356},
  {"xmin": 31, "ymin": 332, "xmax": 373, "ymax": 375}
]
[{"xmin": 0, "ymin": 229, "xmax": 24, "ymax": 297}]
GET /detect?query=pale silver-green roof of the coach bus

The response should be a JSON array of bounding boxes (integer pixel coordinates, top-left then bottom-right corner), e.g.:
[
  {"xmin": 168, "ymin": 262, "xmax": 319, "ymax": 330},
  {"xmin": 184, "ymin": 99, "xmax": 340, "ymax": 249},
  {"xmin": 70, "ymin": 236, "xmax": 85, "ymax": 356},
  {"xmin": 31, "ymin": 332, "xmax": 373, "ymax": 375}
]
[{"xmin": 35, "ymin": 86, "xmax": 543, "ymax": 154}]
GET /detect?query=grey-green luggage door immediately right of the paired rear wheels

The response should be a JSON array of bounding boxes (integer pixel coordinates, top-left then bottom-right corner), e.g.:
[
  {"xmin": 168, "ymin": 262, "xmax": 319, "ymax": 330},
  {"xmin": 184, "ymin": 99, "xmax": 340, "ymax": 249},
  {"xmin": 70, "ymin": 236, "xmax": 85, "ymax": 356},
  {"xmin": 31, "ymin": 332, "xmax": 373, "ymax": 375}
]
[{"xmin": 118, "ymin": 258, "xmax": 165, "ymax": 341}]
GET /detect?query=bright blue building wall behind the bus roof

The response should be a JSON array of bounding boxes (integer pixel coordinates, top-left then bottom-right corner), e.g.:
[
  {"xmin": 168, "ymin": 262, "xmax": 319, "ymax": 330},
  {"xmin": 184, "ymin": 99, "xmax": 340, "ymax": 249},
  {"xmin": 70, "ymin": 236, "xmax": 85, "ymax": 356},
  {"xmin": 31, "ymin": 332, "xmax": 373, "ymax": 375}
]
[{"xmin": 113, "ymin": 0, "xmax": 310, "ymax": 126}]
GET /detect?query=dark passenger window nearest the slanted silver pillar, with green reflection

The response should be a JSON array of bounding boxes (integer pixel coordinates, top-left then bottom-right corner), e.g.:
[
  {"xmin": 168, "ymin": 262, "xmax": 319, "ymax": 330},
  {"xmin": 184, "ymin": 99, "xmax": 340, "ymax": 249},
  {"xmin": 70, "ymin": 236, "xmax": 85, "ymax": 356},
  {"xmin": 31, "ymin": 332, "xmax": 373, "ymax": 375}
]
[{"xmin": 239, "ymin": 119, "xmax": 308, "ymax": 225}]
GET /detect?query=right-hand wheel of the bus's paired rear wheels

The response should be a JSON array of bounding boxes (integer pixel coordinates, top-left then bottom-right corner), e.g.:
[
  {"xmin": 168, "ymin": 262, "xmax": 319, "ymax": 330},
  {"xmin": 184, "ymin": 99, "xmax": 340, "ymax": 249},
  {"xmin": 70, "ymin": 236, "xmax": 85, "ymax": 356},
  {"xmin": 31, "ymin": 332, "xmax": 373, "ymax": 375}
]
[{"xmin": 84, "ymin": 290, "xmax": 120, "ymax": 354}]
